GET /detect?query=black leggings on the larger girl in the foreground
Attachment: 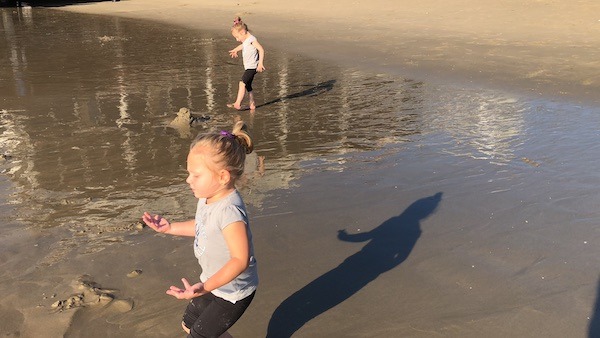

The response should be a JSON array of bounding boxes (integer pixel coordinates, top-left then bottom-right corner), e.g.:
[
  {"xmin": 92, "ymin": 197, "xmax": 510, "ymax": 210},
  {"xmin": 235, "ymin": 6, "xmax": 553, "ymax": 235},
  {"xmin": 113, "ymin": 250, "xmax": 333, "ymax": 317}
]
[{"xmin": 183, "ymin": 292, "xmax": 255, "ymax": 338}]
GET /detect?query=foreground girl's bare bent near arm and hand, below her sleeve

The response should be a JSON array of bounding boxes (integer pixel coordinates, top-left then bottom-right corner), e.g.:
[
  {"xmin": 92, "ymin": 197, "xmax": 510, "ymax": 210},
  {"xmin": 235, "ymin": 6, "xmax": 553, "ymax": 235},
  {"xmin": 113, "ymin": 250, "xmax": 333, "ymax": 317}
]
[{"xmin": 167, "ymin": 221, "xmax": 250, "ymax": 299}]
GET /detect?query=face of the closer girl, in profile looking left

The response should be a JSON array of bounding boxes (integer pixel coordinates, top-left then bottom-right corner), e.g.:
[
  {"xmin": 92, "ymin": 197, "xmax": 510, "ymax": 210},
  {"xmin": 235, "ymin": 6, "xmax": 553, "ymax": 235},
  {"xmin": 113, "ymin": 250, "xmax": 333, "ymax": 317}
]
[{"xmin": 185, "ymin": 145, "xmax": 228, "ymax": 200}]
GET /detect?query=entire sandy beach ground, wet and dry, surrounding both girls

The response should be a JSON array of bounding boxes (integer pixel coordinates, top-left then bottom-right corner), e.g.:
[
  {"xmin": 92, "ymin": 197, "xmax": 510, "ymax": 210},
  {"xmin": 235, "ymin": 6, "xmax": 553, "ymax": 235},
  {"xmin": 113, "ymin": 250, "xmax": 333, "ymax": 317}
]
[{"xmin": 0, "ymin": 0, "xmax": 600, "ymax": 337}]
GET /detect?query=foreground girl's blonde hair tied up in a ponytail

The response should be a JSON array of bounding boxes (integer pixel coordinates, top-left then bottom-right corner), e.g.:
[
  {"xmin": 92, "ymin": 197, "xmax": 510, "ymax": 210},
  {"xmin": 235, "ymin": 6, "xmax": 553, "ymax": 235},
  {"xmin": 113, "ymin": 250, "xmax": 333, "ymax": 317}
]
[{"xmin": 190, "ymin": 121, "xmax": 254, "ymax": 182}]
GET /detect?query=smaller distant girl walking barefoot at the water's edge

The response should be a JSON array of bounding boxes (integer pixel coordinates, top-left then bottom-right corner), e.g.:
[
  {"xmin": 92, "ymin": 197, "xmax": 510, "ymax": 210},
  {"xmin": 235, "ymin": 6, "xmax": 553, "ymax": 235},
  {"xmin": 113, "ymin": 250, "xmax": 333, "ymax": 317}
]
[{"xmin": 227, "ymin": 16, "xmax": 265, "ymax": 110}]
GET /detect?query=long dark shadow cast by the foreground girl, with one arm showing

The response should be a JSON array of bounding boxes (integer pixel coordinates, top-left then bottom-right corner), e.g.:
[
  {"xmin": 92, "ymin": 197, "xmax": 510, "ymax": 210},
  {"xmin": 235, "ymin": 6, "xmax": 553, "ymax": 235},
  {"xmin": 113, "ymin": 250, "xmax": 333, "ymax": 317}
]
[{"xmin": 267, "ymin": 192, "xmax": 442, "ymax": 338}]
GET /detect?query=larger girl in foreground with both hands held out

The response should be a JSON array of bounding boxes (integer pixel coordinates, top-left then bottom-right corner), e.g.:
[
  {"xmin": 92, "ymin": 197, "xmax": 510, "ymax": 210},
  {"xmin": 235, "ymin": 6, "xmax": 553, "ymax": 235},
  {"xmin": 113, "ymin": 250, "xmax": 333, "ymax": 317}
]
[{"xmin": 142, "ymin": 121, "xmax": 258, "ymax": 338}]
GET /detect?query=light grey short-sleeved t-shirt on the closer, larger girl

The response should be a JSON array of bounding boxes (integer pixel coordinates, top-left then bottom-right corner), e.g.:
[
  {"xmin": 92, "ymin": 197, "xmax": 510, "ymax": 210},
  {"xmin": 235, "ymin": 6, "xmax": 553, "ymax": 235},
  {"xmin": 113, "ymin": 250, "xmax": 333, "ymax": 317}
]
[{"xmin": 194, "ymin": 190, "xmax": 258, "ymax": 303}]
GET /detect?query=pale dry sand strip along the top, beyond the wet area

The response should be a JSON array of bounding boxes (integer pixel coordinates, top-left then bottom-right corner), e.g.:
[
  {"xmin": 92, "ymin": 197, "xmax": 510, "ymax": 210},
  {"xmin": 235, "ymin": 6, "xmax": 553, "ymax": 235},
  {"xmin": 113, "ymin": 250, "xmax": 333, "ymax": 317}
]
[{"xmin": 52, "ymin": 0, "xmax": 600, "ymax": 104}]
